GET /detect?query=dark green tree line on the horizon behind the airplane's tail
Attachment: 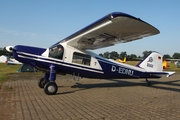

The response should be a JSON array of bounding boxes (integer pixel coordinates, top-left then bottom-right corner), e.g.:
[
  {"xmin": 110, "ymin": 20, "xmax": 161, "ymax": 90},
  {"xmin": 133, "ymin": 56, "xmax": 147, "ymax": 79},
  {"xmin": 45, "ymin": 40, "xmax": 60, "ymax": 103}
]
[{"xmin": 99, "ymin": 51, "xmax": 180, "ymax": 60}]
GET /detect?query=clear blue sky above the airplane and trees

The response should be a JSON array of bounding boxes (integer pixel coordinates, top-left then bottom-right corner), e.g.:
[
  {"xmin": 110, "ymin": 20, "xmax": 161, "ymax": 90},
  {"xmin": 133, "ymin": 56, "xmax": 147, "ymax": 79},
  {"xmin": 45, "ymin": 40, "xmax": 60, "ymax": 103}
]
[{"xmin": 0, "ymin": 0, "xmax": 180, "ymax": 56}]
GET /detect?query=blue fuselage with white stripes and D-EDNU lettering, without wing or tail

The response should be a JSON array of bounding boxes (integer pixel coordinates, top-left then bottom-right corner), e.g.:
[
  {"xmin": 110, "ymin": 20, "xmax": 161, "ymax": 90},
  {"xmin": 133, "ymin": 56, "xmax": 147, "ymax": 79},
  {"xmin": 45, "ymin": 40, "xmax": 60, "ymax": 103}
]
[{"xmin": 13, "ymin": 45, "xmax": 160, "ymax": 79}]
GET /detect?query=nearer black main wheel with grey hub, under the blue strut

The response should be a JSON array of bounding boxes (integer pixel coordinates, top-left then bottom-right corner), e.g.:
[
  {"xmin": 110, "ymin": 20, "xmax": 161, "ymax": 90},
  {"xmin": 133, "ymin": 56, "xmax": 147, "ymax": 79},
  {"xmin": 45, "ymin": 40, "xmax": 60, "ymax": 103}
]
[{"xmin": 44, "ymin": 82, "xmax": 58, "ymax": 95}]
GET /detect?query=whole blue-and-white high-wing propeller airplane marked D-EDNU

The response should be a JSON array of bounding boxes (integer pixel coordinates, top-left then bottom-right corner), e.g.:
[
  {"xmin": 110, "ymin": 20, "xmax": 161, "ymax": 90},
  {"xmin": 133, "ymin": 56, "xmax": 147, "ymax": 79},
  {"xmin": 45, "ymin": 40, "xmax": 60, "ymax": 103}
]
[{"xmin": 6, "ymin": 12, "xmax": 175, "ymax": 95}]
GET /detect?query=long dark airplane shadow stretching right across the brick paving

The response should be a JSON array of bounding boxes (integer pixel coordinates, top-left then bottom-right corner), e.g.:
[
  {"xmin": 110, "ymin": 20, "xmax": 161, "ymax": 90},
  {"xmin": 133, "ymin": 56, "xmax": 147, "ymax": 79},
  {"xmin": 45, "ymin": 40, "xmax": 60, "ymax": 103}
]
[{"xmin": 57, "ymin": 79, "xmax": 180, "ymax": 94}]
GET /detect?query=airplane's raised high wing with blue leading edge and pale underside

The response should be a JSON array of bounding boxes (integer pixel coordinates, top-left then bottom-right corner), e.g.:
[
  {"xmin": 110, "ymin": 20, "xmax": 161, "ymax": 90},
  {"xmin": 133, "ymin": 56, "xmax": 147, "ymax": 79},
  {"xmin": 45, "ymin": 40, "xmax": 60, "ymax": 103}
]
[{"xmin": 52, "ymin": 12, "xmax": 160, "ymax": 50}]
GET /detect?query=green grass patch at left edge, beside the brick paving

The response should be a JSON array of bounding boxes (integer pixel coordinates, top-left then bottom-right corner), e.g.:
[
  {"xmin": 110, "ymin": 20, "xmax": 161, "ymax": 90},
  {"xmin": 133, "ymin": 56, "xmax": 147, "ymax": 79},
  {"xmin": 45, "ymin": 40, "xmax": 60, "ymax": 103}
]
[{"xmin": 0, "ymin": 63, "xmax": 21, "ymax": 88}]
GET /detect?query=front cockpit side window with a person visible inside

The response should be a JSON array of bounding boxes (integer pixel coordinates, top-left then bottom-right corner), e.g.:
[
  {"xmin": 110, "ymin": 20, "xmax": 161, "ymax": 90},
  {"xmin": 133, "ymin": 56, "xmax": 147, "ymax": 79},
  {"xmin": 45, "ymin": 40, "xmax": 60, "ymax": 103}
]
[{"xmin": 49, "ymin": 45, "xmax": 64, "ymax": 59}]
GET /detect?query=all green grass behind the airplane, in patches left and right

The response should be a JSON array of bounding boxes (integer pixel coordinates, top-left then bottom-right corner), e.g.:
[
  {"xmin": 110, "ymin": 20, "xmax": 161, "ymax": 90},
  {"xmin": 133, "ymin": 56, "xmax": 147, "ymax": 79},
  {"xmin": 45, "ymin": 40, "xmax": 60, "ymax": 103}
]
[{"xmin": 0, "ymin": 61, "xmax": 180, "ymax": 88}]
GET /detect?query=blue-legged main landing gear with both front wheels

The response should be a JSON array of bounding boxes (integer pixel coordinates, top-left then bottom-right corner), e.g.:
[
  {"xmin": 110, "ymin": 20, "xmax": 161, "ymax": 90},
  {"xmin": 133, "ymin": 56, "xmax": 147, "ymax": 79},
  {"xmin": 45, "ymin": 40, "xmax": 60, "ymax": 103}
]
[{"xmin": 38, "ymin": 65, "xmax": 58, "ymax": 95}]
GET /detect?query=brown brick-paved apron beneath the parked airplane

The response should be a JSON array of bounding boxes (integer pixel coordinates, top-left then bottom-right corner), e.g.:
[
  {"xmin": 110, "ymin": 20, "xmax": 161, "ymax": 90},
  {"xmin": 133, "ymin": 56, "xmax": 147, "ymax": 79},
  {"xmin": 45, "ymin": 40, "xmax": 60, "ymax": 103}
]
[{"xmin": 0, "ymin": 73, "xmax": 180, "ymax": 120}]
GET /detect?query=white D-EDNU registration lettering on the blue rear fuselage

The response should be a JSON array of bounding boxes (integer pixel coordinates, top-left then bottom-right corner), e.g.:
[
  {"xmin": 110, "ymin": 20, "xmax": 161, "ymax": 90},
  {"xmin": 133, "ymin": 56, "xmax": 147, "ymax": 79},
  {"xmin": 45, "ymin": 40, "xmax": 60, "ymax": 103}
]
[{"xmin": 111, "ymin": 66, "xmax": 134, "ymax": 76}]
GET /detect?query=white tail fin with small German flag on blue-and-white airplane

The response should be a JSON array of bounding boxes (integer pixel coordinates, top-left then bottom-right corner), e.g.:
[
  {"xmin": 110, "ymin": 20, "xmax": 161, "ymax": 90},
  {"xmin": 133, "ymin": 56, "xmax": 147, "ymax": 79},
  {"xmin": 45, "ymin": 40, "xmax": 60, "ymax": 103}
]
[{"xmin": 136, "ymin": 52, "xmax": 163, "ymax": 71}]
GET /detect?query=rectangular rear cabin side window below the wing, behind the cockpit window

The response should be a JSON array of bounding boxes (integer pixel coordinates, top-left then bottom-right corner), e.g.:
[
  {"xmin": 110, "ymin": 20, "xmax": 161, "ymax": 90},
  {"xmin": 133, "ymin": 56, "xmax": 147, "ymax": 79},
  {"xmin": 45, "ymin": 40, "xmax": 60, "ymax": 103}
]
[{"xmin": 72, "ymin": 52, "xmax": 91, "ymax": 66}]
